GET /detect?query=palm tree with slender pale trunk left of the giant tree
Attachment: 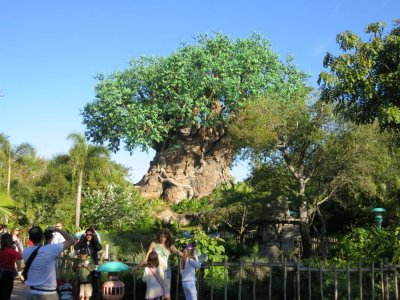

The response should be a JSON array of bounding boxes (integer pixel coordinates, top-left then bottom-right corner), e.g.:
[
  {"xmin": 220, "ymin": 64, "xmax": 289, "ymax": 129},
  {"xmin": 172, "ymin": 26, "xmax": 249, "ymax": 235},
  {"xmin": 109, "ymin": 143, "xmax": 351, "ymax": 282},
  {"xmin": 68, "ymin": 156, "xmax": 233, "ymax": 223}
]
[{"xmin": 67, "ymin": 133, "xmax": 110, "ymax": 228}]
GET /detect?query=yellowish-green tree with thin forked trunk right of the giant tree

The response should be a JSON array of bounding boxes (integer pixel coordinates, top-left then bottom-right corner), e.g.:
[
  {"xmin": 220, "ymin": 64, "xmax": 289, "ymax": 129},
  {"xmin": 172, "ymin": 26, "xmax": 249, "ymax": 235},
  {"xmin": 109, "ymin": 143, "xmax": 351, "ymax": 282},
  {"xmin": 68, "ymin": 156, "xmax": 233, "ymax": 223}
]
[{"xmin": 230, "ymin": 97, "xmax": 396, "ymax": 256}]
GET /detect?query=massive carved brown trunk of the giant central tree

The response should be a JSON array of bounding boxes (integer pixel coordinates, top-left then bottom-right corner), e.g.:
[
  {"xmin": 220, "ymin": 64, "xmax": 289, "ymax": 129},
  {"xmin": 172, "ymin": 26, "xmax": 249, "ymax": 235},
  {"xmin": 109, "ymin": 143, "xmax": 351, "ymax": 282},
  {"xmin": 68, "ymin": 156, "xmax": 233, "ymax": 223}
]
[{"xmin": 137, "ymin": 128, "xmax": 232, "ymax": 203}]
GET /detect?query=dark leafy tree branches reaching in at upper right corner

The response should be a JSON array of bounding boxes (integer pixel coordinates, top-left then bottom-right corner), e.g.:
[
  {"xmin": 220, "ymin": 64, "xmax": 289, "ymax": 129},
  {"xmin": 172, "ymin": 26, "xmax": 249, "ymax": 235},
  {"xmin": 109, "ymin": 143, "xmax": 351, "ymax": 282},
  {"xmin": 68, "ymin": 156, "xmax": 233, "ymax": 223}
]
[{"xmin": 318, "ymin": 20, "xmax": 400, "ymax": 130}]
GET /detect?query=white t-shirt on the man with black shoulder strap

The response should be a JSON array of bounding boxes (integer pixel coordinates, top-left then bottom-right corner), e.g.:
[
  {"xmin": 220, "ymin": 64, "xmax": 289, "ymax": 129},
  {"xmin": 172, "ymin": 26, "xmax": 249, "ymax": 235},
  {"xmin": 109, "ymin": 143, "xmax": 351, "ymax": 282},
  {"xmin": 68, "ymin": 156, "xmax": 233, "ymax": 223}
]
[{"xmin": 23, "ymin": 244, "xmax": 64, "ymax": 294}]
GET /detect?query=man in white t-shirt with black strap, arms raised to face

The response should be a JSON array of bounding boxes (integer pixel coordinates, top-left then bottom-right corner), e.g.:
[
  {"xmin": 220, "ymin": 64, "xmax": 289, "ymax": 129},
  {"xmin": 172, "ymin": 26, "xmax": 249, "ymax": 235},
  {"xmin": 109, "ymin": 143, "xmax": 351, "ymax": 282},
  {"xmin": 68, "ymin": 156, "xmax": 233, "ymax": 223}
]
[{"xmin": 23, "ymin": 226, "xmax": 75, "ymax": 300}]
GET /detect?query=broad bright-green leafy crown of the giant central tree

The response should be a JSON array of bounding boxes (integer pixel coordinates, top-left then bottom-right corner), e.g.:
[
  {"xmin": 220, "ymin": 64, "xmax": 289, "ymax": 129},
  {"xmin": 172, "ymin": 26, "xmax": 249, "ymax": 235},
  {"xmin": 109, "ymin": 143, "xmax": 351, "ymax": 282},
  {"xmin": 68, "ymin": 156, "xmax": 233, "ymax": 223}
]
[{"xmin": 83, "ymin": 34, "xmax": 306, "ymax": 151}]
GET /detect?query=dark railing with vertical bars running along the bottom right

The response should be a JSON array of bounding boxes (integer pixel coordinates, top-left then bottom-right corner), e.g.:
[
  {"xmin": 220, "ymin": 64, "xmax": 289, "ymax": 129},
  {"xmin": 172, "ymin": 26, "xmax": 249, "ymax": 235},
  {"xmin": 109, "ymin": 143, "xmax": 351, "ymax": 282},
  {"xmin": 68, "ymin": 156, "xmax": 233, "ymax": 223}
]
[{"xmin": 57, "ymin": 258, "xmax": 400, "ymax": 300}]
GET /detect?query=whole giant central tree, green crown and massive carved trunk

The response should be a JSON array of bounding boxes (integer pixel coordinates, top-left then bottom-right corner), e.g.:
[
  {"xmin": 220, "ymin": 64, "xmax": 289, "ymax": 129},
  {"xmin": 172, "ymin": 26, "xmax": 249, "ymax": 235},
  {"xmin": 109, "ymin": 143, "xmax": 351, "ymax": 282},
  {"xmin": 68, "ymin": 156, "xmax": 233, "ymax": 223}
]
[{"xmin": 83, "ymin": 34, "xmax": 307, "ymax": 203}]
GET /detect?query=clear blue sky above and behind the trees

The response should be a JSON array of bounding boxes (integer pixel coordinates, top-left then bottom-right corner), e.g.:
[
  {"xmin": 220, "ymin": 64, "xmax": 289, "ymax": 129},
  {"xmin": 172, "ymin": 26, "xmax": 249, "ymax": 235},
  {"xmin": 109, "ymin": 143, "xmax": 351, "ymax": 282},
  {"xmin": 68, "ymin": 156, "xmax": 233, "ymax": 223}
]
[{"xmin": 0, "ymin": 0, "xmax": 400, "ymax": 181}]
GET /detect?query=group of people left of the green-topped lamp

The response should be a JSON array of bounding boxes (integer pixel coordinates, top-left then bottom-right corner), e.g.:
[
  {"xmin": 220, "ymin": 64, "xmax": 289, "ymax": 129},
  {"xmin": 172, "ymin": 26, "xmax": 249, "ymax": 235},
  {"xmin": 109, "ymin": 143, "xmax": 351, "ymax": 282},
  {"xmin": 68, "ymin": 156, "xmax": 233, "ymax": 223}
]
[{"xmin": 0, "ymin": 223, "xmax": 102, "ymax": 300}]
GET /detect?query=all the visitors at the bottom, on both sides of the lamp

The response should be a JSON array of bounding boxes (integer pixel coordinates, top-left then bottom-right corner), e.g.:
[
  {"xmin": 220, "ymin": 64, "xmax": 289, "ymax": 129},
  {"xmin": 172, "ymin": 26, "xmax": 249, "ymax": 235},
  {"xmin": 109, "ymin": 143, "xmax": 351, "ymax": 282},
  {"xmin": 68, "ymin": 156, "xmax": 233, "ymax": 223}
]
[{"xmin": 0, "ymin": 223, "xmax": 202, "ymax": 300}]
